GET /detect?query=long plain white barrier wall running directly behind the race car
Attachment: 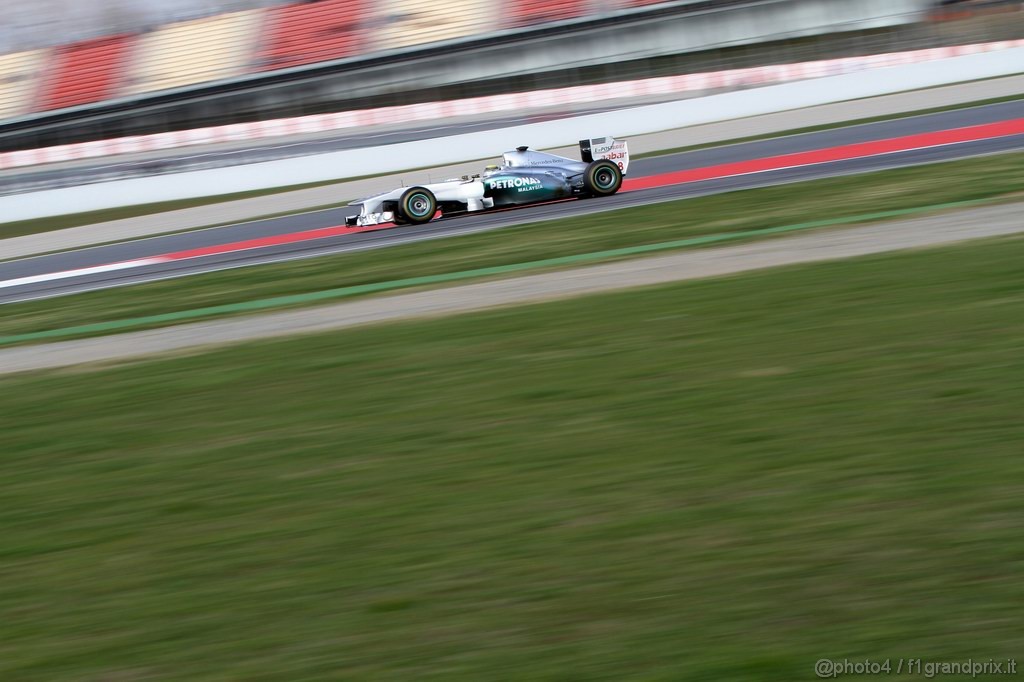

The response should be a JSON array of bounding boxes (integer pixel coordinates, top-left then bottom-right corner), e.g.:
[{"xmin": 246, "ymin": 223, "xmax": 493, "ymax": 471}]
[{"xmin": 0, "ymin": 47, "xmax": 1024, "ymax": 221}]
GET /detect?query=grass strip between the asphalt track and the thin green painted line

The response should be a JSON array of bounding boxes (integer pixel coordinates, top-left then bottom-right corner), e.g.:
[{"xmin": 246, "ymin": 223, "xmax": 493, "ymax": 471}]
[{"xmin": 6, "ymin": 153, "xmax": 1024, "ymax": 346}]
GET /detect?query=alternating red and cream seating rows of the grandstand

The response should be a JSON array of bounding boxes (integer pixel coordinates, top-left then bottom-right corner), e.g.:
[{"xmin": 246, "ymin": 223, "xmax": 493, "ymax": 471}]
[{"xmin": 0, "ymin": 0, "xmax": 638, "ymax": 120}]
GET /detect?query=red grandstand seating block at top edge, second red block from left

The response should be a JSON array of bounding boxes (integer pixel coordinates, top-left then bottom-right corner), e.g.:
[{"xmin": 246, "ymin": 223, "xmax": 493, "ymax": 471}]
[{"xmin": 255, "ymin": 0, "xmax": 372, "ymax": 71}]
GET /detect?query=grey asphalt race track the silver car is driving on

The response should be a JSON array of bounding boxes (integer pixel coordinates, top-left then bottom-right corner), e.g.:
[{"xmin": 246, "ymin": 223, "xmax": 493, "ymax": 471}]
[{"xmin": 0, "ymin": 100, "xmax": 1024, "ymax": 303}]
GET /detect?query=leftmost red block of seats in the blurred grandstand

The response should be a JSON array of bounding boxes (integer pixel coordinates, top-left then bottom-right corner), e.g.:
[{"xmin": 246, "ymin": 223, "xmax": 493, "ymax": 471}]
[{"xmin": 39, "ymin": 36, "xmax": 134, "ymax": 111}]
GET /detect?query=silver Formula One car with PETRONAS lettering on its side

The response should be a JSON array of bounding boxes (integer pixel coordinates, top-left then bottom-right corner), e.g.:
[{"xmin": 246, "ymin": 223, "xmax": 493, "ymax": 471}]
[{"xmin": 346, "ymin": 137, "xmax": 630, "ymax": 226}]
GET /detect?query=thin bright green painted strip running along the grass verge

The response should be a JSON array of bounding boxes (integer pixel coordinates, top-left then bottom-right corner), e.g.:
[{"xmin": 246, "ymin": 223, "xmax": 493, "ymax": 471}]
[{"xmin": 0, "ymin": 199, "xmax": 992, "ymax": 345}]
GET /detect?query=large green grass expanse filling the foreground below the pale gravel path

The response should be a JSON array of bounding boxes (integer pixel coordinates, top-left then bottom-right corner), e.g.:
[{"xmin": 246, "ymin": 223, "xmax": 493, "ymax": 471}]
[{"xmin": 0, "ymin": 239, "xmax": 1024, "ymax": 682}]
